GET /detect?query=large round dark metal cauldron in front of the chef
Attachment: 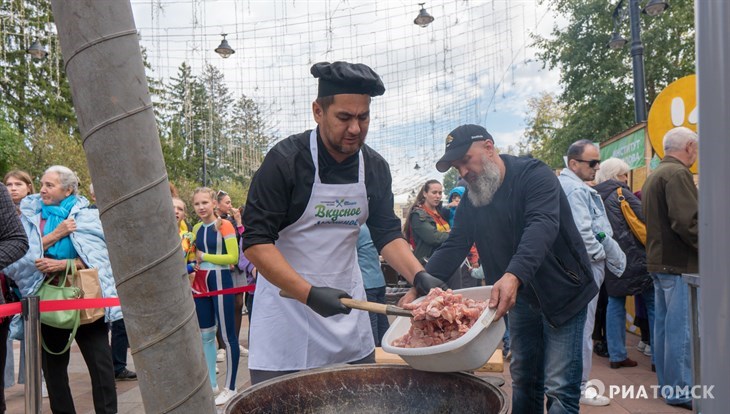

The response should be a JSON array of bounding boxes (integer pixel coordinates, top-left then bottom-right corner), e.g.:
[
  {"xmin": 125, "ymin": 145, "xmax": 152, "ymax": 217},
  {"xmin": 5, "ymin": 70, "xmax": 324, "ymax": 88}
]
[{"xmin": 225, "ymin": 365, "xmax": 507, "ymax": 414}]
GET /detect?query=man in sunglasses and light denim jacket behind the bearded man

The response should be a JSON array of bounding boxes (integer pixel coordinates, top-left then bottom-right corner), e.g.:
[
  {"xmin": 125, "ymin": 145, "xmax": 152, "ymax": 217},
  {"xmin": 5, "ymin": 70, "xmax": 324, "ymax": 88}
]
[{"xmin": 559, "ymin": 139, "xmax": 624, "ymax": 406}]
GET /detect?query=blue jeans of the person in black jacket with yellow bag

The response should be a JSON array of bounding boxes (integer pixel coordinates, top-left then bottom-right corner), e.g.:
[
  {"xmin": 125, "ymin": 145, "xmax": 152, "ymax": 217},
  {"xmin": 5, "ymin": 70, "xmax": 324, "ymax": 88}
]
[{"xmin": 606, "ymin": 288, "xmax": 654, "ymax": 362}]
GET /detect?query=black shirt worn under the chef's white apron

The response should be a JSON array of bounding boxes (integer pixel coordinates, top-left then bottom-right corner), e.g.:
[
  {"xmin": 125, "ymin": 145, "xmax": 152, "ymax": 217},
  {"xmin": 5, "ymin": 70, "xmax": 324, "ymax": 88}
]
[{"xmin": 243, "ymin": 131, "xmax": 402, "ymax": 251}]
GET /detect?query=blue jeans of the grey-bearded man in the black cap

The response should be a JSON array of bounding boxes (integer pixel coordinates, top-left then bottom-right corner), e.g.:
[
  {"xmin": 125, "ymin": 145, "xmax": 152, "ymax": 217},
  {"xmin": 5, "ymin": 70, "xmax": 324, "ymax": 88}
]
[{"xmin": 509, "ymin": 295, "xmax": 586, "ymax": 414}]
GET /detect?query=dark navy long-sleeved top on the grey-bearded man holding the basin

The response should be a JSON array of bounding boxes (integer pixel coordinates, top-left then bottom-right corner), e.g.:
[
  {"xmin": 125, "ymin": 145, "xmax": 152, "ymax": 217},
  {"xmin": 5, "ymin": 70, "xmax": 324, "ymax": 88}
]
[{"xmin": 426, "ymin": 155, "xmax": 598, "ymax": 326}]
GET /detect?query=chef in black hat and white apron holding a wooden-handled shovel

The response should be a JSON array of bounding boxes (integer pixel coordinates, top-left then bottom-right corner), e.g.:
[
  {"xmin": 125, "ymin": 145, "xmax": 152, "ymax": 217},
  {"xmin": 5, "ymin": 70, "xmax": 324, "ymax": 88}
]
[{"xmin": 243, "ymin": 62, "xmax": 445, "ymax": 384}]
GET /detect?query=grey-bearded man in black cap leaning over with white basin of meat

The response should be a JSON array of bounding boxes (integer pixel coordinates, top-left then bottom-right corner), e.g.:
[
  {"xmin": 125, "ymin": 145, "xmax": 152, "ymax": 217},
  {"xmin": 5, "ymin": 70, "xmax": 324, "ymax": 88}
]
[{"xmin": 426, "ymin": 125, "xmax": 598, "ymax": 413}]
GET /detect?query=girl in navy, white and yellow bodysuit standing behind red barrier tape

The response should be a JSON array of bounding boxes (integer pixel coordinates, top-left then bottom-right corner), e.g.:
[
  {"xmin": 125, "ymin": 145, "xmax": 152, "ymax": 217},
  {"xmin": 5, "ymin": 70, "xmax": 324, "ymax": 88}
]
[{"xmin": 193, "ymin": 187, "xmax": 240, "ymax": 405}]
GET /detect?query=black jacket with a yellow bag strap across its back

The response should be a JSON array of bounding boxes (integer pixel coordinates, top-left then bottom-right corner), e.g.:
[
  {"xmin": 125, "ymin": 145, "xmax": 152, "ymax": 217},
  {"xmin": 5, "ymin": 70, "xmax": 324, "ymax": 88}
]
[{"xmin": 593, "ymin": 180, "xmax": 653, "ymax": 296}]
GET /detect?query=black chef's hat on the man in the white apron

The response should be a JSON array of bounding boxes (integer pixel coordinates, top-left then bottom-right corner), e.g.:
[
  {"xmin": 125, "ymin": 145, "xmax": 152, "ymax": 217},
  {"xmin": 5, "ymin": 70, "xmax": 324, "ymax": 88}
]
[{"xmin": 310, "ymin": 62, "xmax": 385, "ymax": 98}]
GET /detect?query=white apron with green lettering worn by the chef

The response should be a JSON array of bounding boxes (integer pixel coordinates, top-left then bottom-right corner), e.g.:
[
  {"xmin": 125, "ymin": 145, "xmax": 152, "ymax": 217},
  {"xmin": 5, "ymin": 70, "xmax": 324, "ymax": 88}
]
[{"xmin": 248, "ymin": 129, "xmax": 375, "ymax": 371}]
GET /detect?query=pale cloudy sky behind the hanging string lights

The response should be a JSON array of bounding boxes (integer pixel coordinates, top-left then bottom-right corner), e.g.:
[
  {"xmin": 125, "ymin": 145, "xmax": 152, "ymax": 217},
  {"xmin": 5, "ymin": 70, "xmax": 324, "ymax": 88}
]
[{"xmin": 131, "ymin": 0, "xmax": 560, "ymax": 194}]
